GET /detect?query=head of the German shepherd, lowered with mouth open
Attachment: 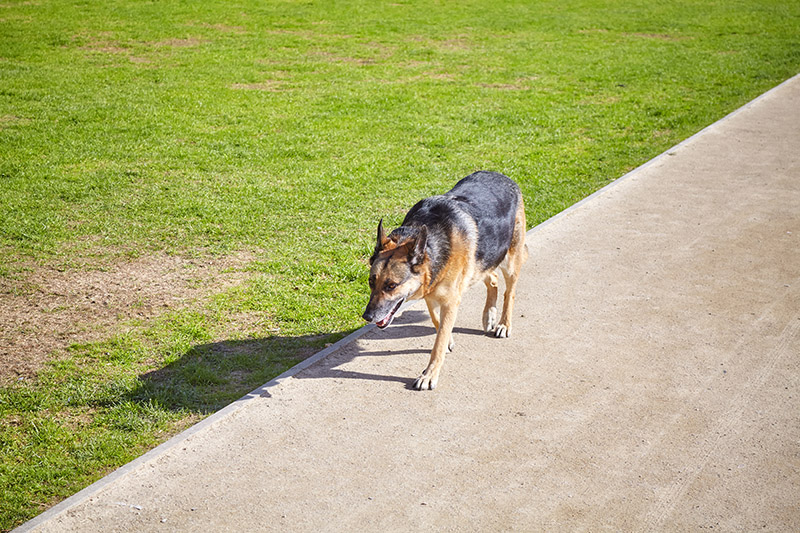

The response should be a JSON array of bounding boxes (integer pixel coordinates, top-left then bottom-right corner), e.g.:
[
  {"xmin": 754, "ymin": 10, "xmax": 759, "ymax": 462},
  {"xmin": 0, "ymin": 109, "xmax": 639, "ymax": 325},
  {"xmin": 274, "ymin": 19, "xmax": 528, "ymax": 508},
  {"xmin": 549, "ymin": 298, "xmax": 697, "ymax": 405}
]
[{"xmin": 363, "ymin": 220, "xmax": 428, "ymax": 328}]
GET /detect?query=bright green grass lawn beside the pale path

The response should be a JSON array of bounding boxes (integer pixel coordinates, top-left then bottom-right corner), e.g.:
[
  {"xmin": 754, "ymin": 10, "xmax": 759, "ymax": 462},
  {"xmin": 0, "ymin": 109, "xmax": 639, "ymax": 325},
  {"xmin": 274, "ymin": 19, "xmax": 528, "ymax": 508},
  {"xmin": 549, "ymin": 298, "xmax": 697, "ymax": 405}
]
[{"xmin": 0, "ymin": 0, "xmax": 800, "ymax": 529}]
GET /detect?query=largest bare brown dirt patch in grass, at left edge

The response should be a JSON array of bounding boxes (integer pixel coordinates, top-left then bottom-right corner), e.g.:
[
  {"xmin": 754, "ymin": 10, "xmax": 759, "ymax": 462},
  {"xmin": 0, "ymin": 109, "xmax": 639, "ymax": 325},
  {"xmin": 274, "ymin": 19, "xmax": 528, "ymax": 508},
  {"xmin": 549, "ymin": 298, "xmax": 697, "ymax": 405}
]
[{"xmin": 0, "ymin": 252, "xmax": 256, "ymax": 384}]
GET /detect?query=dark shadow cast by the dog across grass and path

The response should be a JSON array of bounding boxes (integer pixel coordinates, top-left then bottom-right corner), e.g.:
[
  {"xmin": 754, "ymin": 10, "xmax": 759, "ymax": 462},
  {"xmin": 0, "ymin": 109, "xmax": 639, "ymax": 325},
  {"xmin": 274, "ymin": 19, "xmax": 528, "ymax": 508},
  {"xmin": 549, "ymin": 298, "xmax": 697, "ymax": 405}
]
[{"xmin": 130, "ymin": 309, "xmax": 483, "ymax": 414}]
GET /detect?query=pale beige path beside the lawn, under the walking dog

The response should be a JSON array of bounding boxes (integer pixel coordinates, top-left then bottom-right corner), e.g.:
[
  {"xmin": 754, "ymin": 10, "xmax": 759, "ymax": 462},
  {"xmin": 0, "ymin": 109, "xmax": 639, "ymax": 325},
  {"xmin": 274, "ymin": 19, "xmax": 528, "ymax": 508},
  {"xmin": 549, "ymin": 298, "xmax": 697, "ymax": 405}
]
[{"xmin": 15, "ymin": 77, "xmax": 800, "ymax": 532}]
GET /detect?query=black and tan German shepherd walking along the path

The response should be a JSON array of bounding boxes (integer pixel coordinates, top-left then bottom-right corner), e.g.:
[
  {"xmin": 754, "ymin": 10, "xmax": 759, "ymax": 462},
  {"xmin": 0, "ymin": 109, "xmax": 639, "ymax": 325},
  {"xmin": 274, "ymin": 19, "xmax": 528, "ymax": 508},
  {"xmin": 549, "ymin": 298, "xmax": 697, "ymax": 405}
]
[{"xmin": 363, "ymin": 171, "xmax": 527, "ymax": 390}]
